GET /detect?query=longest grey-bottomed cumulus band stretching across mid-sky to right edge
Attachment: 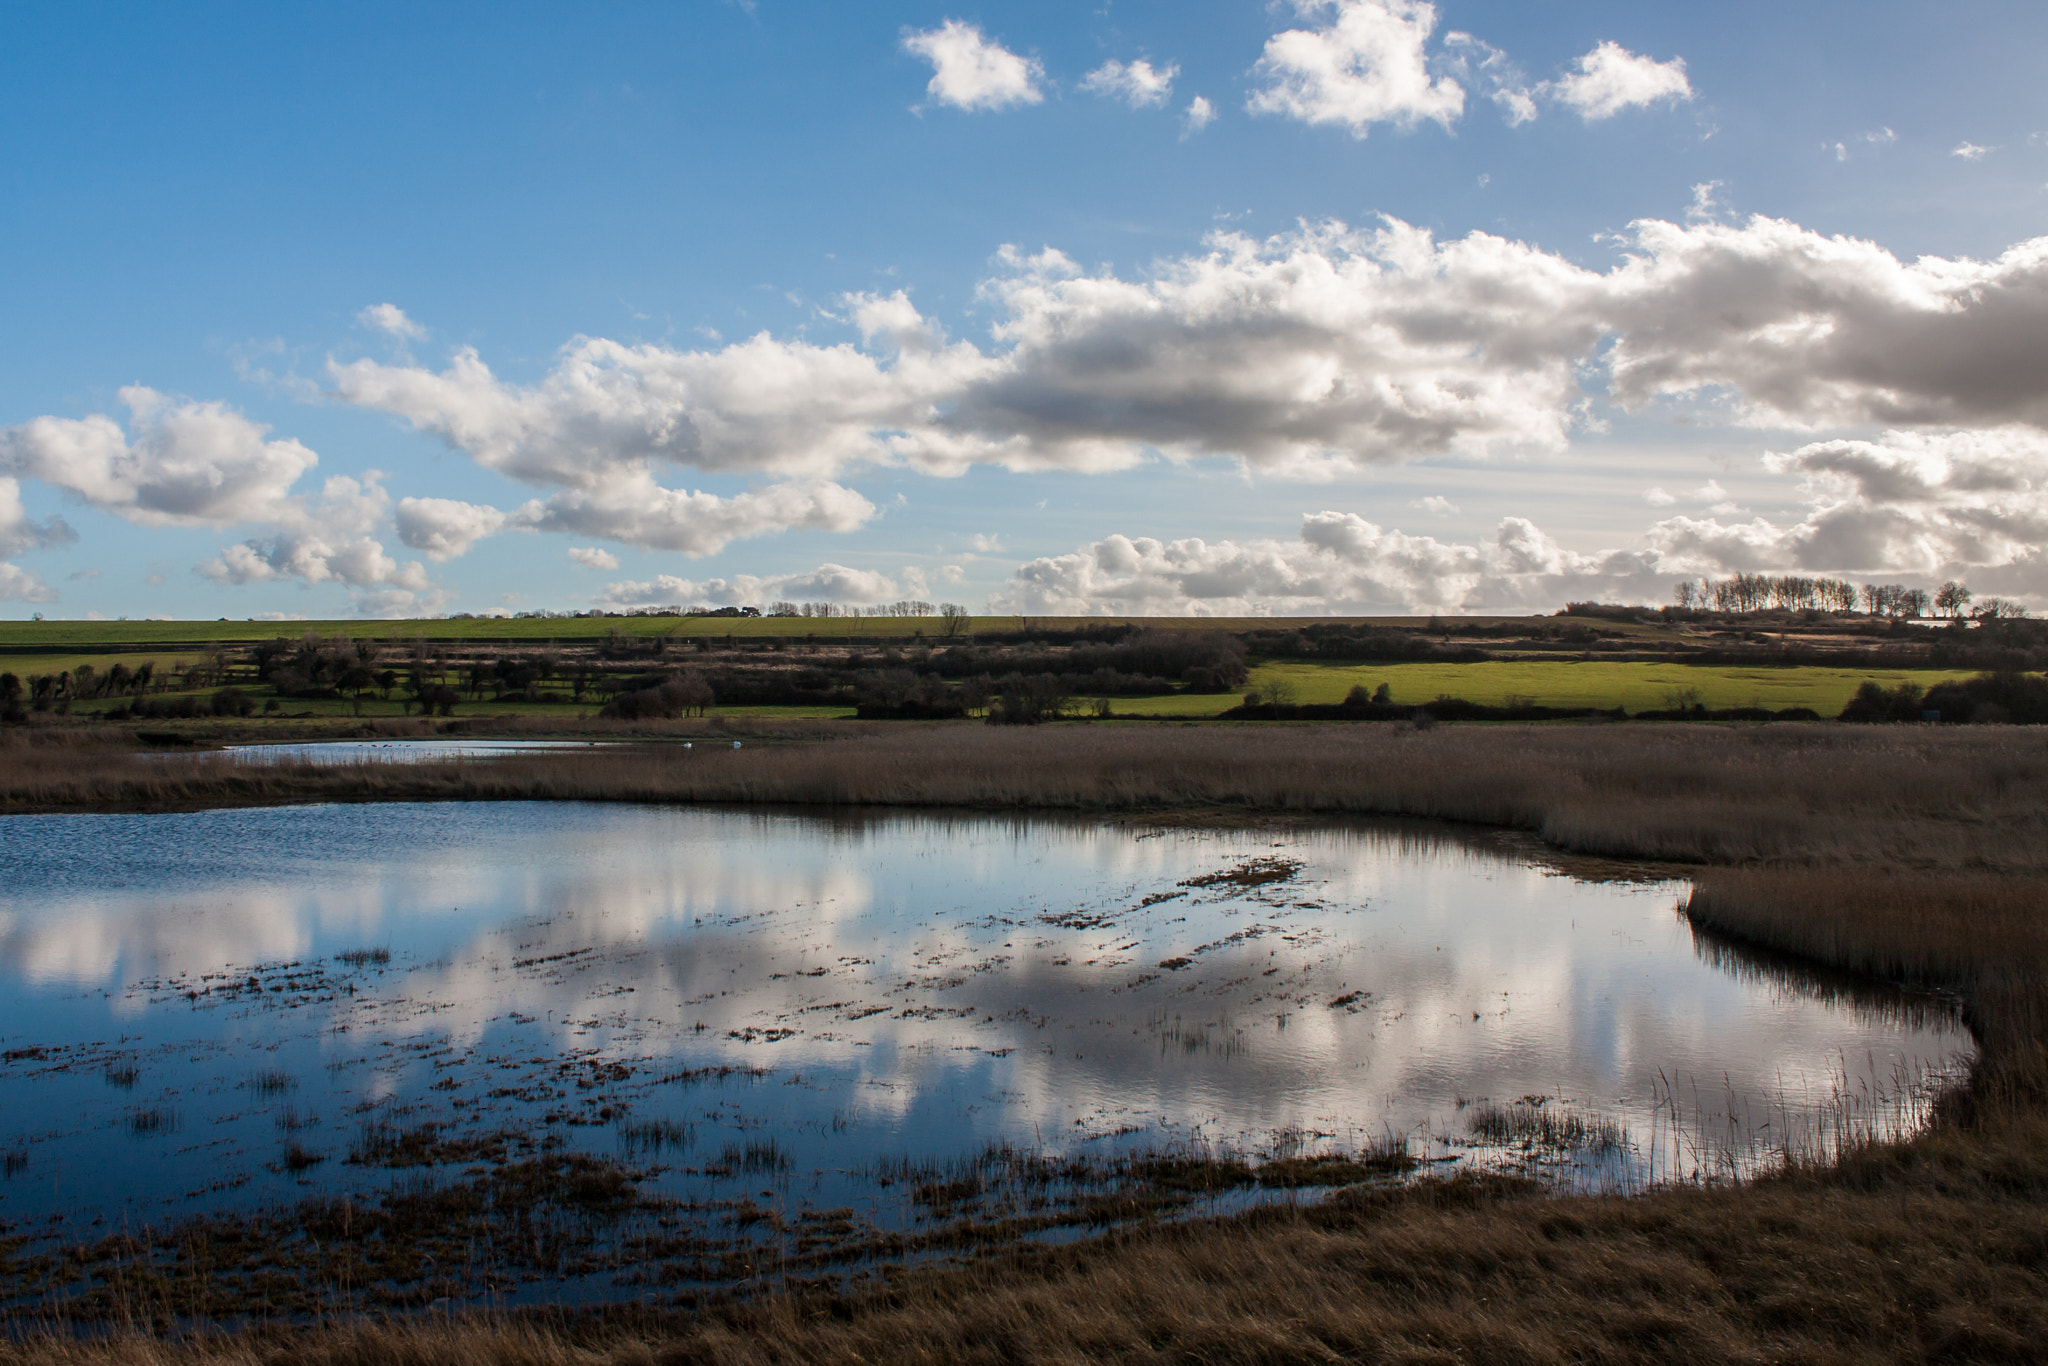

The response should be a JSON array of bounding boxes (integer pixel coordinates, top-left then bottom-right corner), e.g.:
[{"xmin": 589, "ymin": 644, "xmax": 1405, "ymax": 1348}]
[{"xmin": 332, "ymin": 219, "xmax": 2048, "ymax": 501}]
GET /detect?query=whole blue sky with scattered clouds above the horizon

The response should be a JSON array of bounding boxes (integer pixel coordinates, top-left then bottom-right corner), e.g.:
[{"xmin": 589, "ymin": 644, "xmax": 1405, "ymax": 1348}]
[{"xmin": 0, "ymin": 0, "xmax": 2048, "ymax": 618}]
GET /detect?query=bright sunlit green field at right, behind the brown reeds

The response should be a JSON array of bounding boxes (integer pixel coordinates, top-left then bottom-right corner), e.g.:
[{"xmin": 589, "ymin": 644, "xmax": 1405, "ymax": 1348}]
[{"xmin": 1112, "ymin": 659, "xmax": 1970, "ymax": 717}]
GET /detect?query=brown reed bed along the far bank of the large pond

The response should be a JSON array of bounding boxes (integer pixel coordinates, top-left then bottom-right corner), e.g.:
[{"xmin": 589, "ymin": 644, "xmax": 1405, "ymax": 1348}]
[{"xmin": 0, "ymin": 725, "xmax": 2048, "ymax": 872}]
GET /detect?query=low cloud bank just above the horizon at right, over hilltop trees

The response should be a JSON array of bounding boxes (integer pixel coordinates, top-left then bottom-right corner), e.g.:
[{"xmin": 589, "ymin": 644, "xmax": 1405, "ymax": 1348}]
[{"xmin": 991, "ymin": 428, "xmax": 2048, "ymax": 616}]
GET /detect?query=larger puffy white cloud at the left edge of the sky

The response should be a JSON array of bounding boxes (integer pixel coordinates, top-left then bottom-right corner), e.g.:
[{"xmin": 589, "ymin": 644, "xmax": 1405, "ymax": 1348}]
[{"xmin": 0, "ymin": 385, "xmax": 319, "ymax": 526}]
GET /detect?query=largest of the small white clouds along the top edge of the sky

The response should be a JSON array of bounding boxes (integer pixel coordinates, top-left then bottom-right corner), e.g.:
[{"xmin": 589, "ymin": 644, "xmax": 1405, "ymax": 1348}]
[{"xmin": 1245, "ymin": 0, "xmax": 1464, "ymax": 137}]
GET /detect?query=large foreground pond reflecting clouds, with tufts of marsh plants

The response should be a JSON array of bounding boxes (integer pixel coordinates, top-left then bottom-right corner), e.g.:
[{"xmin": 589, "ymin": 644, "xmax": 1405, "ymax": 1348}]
[{"xmin": 0, "ymin": 803, "xmax": 1972, "ymax": 1310}]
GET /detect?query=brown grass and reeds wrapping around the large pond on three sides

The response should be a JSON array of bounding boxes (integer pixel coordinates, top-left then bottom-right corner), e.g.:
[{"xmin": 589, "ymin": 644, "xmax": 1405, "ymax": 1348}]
[{"xmin": 0, "ymin": 727, "xmax": 2048, "ymax": 1366}]
